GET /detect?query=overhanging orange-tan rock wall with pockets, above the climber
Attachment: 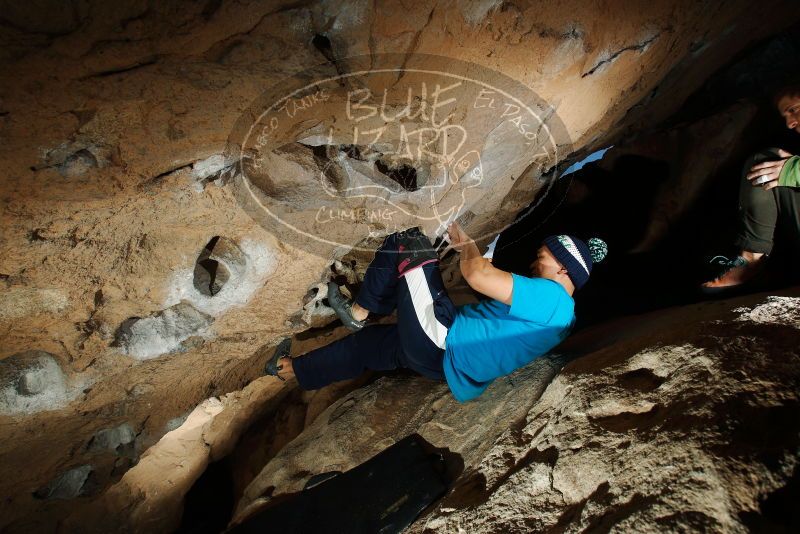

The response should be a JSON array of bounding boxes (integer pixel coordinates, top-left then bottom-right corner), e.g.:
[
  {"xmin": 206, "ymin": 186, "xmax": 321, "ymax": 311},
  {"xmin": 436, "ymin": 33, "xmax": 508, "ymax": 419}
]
[{"xmin": 0, "ymin": 0, "xmax": 797, "ymax": 531}]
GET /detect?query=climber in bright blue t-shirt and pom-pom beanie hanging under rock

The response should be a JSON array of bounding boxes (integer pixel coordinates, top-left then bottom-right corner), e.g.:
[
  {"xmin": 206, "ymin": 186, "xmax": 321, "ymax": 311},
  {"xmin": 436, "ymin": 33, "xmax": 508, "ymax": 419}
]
[{"xmin": 265, "ymin": 223, "xmax": 606, "ymax": 402}]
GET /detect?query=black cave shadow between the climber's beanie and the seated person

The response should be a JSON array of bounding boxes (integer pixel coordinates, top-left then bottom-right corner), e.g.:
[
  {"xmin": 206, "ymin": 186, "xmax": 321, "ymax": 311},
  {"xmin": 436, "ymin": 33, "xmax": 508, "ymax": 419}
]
[{"xmin": 494, "ymin": 130, "xmax": 800, "ymax": 330}]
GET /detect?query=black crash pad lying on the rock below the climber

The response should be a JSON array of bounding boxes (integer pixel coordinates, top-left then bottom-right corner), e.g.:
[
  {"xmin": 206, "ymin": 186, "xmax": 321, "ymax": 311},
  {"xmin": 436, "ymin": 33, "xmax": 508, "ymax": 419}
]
[{"xmin": 229, "ymin": 434, "xmax": 447, "ymax": 534}]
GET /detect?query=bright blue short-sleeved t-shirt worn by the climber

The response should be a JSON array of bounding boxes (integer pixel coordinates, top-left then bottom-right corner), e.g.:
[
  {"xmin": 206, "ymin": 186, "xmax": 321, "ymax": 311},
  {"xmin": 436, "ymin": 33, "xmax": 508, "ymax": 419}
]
[{"xmin": 443, "ymin": 273, "xmax": 575, "ymax": 402}]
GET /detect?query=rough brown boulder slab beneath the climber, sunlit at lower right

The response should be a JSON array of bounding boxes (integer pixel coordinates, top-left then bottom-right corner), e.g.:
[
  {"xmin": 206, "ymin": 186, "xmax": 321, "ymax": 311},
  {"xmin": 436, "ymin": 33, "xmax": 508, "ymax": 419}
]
[{"xmin": 231, "ymin": 290, "xmax": 800, "ymax": 532}]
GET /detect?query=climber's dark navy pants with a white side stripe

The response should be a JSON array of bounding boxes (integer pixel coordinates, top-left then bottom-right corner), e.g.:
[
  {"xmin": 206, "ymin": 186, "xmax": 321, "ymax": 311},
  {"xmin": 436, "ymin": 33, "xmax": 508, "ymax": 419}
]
[{"xmin": 292, "ymin": 234, "xmax": 456, "ymax": 389}]
